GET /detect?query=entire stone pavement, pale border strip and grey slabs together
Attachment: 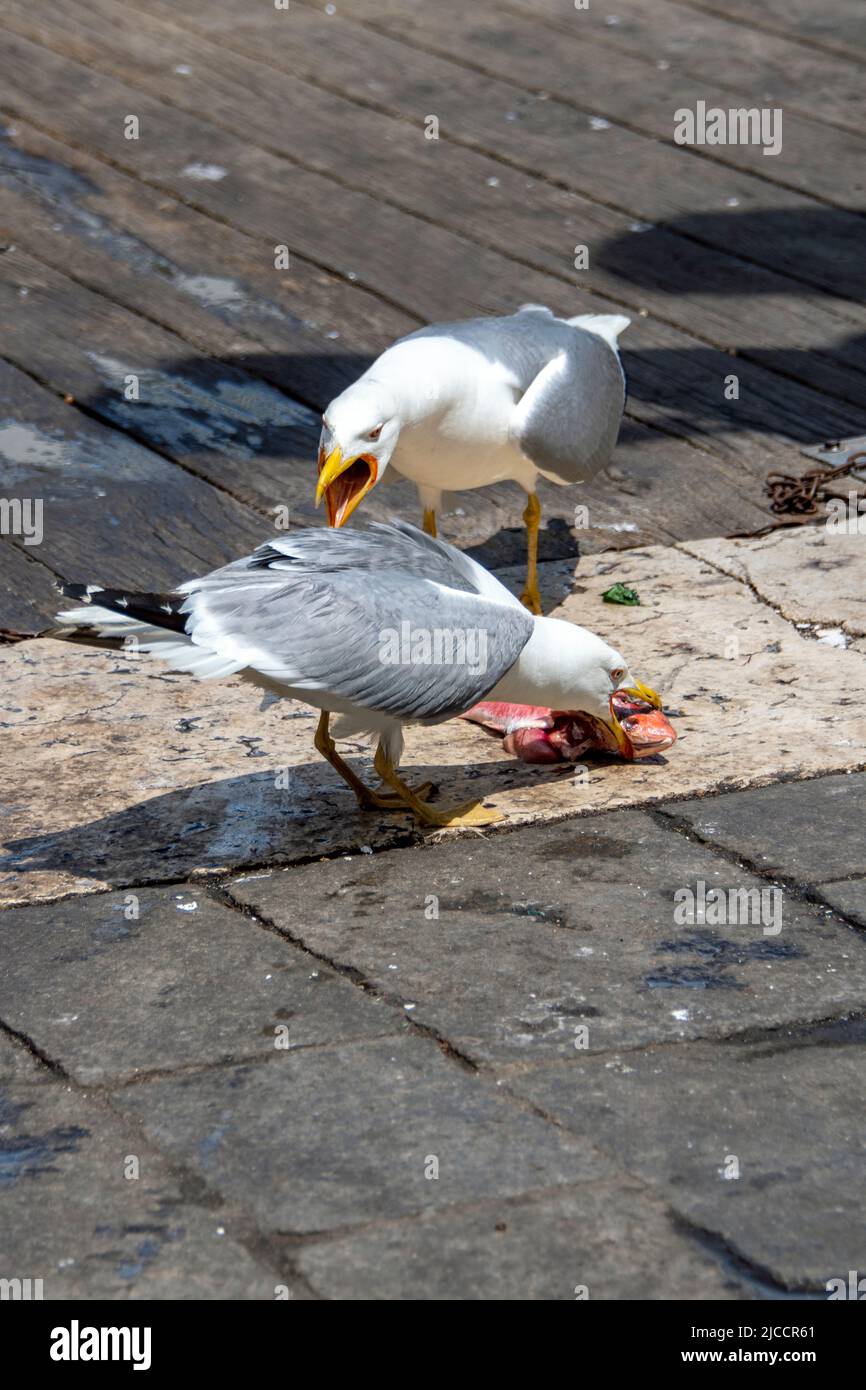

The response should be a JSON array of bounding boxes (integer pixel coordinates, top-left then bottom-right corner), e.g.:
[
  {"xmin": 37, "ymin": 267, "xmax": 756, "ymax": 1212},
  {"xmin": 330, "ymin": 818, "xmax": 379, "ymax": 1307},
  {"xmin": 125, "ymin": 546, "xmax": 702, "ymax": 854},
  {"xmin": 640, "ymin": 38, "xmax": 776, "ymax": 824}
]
[{"xmin": 0, "ymin": 531, "xmax": 866, "ymax": 1300}]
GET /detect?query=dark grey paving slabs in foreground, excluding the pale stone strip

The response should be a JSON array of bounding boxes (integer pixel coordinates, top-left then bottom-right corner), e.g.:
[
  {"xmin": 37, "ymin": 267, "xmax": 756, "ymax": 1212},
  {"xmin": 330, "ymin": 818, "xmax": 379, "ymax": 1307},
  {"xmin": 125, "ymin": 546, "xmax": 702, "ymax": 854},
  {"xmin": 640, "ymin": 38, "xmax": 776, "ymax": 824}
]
[{"xmin": 0, "ymin": 774, "xmax": 866, "ymax": 1300}]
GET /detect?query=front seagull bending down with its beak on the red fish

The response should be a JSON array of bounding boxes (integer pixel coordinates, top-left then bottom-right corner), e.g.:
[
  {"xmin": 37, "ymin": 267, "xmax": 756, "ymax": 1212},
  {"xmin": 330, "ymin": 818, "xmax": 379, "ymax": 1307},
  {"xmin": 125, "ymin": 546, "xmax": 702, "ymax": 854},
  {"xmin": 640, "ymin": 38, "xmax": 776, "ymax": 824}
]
[{"xmin": 52, "ymin": 521, "xmax": 660, "ymax": 827}]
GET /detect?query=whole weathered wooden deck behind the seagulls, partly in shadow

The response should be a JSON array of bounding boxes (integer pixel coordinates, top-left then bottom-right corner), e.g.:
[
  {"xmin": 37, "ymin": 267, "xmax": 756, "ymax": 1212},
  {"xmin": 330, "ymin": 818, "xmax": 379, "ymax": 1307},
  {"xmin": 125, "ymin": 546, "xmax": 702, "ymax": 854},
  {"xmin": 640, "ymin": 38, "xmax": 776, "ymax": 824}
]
[{"xmin": 0, "ymin": 0, "xmax": 866, "ymax": 634}]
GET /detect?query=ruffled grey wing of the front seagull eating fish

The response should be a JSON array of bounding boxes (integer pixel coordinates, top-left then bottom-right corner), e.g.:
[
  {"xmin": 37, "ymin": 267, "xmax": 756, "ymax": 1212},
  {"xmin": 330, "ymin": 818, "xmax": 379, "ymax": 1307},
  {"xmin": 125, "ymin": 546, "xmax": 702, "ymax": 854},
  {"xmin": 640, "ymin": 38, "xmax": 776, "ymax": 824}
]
[{"xmin": 183, "ymin": 558, "xmax": 532, "ymax": 721}]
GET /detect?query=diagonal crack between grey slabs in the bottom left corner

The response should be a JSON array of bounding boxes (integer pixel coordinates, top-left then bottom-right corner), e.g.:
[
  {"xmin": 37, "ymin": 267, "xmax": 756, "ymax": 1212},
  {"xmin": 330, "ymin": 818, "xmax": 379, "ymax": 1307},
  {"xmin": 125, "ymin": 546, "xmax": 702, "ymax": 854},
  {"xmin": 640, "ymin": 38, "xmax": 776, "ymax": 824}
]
[{"xmin": 0, "ymin": 1022, "xmax": 321, "ymax": 1300}]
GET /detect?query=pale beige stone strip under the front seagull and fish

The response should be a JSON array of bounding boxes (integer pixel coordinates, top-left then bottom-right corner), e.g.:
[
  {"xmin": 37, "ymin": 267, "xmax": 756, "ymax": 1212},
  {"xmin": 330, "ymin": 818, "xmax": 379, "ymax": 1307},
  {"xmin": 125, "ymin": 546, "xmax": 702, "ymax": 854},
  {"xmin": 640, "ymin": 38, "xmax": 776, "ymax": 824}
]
[{"xmin": 6, "ymin": 525, "xmax": 866, "ymax": 902}]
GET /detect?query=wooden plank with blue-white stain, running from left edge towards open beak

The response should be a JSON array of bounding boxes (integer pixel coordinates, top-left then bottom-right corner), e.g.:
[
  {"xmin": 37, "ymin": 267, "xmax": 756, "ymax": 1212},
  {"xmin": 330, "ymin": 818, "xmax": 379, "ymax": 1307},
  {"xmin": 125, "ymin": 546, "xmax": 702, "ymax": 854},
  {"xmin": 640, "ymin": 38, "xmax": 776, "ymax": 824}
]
[{"xmin": 0, "ymin": 249, "xmax": 321, "ymax": 522}]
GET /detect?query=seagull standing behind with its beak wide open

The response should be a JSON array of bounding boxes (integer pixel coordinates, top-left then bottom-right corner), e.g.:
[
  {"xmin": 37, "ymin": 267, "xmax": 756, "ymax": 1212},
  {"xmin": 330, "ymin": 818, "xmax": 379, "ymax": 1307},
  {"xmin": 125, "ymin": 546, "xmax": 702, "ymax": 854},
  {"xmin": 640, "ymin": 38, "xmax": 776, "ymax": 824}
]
[{"xmin": 316, "ymin": 304, "xmax": 631, "ymax": 613}]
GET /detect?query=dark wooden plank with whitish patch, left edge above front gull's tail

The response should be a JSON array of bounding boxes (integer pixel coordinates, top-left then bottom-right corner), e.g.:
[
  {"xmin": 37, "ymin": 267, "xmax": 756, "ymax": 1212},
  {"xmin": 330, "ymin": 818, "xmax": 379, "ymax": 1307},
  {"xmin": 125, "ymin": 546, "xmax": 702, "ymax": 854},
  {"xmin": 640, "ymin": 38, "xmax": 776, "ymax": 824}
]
[{"xmin": 0, "ymin": 355, "xmax": 268, "ymax": 631}]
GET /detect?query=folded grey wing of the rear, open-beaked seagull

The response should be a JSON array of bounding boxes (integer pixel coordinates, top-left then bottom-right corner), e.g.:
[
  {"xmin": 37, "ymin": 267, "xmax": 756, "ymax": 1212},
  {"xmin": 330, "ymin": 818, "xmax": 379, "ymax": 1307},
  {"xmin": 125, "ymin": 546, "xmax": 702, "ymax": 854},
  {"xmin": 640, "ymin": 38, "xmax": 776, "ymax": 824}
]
[{"xmin": 512, "ymin": 328, "xmax": 626, "ymax": 482}]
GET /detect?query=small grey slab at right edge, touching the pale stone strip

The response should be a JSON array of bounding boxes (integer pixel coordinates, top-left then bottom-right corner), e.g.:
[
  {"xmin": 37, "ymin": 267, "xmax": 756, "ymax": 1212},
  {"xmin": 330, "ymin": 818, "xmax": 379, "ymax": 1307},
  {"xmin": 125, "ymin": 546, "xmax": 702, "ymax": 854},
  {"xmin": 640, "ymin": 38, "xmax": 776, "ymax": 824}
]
[{"xmin": 659, "ymin": 773, "xmax": 866, "ymax": 884}]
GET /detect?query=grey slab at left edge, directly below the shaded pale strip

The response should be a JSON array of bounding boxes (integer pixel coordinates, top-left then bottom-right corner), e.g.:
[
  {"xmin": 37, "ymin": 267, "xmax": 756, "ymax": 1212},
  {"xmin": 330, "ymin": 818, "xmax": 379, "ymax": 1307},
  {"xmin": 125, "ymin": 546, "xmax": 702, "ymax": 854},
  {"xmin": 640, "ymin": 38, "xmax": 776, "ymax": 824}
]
[{"xmin": 0, "ymin": 888, "xmax": 391, "ymax": 1086}]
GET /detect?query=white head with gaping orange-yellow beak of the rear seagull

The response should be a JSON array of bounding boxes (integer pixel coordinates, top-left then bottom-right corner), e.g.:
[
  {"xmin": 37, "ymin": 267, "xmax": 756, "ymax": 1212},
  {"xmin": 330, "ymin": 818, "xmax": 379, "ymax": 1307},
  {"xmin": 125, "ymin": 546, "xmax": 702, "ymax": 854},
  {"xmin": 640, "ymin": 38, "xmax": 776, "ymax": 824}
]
[{"xmin": 316, "ymin": 377, "xmax": 400, "ymax": 525}]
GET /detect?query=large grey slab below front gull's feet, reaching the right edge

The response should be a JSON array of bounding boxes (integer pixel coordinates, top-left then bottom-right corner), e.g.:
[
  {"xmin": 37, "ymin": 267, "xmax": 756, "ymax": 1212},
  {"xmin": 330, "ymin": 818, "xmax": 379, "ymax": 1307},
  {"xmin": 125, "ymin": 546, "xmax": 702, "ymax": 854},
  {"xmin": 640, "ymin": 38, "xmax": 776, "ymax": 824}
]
[{"xmin": 227, "ymin": 806, "xmax": 866, "ymax": 1063}]
